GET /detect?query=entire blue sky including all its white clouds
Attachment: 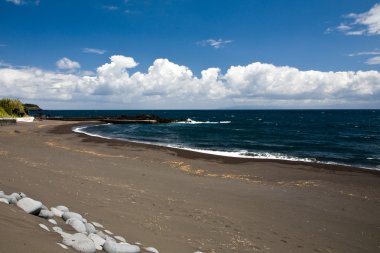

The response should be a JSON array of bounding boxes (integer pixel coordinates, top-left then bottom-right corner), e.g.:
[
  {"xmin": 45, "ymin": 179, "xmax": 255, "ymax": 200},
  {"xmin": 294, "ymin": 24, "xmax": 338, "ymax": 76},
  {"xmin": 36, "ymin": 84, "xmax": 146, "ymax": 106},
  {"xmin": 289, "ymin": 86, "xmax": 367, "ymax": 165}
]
[{"xmin": 0, "ymin": 0, "xmax": 380, "ymax": 109}]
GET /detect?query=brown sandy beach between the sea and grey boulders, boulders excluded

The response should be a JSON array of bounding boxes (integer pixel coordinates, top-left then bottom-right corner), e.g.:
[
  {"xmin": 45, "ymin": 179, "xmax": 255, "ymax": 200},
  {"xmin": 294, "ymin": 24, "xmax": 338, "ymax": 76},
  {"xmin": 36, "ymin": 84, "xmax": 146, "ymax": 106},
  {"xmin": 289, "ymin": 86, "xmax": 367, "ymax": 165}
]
[{"xmin": 0, "ymin": 120, "xmax": 380, "ymax": 253}]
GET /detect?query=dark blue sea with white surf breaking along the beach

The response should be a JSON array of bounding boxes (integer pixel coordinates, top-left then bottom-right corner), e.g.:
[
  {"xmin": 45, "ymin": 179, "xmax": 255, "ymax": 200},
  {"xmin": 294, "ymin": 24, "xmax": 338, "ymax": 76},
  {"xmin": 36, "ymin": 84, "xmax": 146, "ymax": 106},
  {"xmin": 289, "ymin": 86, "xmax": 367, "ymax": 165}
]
[{"xmin": 37, "ymin": 110, "xmax": 380, "ymax": 170}]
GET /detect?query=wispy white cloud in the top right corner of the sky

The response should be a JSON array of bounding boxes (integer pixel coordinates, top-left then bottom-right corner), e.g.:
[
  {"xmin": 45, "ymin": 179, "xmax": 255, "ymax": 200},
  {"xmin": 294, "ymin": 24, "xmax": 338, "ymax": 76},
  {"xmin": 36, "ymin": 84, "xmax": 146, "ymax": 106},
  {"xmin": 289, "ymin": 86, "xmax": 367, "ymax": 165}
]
[{"xmin": 332, "ymin": 3, "xmax": 380, "ymax": 36}]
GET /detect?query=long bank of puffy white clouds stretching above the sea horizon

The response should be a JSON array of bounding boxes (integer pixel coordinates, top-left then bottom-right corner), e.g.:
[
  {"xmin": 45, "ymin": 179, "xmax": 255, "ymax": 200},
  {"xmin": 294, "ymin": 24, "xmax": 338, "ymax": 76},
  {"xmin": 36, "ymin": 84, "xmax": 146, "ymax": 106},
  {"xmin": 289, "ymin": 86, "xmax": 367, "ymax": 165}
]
[{"xmin": 0, "ymin": 55, "xmax": 380, "ymax": 109}]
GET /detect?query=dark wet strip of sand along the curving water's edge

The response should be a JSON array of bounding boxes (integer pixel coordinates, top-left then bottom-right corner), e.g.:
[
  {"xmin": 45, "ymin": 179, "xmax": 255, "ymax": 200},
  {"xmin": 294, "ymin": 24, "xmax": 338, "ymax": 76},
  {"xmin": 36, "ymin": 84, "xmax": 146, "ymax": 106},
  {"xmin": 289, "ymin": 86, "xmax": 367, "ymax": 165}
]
[{"xmin": 52, "ymin": 121, "xmax": 380, "ymax": 176}]
